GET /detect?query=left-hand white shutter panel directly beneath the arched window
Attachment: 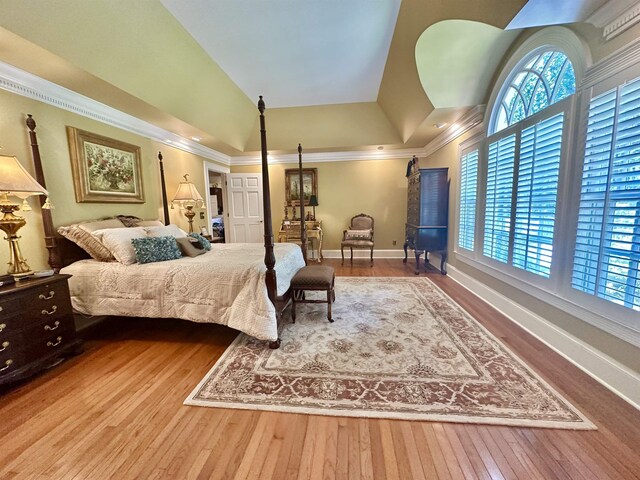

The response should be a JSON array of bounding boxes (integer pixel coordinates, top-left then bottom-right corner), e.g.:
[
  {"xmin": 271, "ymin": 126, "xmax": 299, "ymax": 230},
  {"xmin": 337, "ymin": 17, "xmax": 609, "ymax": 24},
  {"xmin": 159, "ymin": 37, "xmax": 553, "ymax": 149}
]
[{"xmin": 482, "ymin": 134, "xmax": 516, "ymax": 263}]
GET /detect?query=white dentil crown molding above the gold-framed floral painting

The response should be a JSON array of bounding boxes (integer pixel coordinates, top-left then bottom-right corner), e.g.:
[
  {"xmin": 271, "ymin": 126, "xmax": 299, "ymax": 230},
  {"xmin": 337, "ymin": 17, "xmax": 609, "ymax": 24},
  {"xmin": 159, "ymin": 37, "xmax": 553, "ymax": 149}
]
[{"xmin": 0, "ymin": 62, "xmax": 231, "ymax": 165}]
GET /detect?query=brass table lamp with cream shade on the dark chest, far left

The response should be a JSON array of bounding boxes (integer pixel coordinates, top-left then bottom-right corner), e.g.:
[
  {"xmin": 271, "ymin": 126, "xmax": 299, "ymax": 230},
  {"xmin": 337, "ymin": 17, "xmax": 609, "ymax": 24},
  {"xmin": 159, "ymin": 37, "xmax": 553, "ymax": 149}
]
[{"xmin": 0, "ymin": 155, "xmax": 52, "ymax": 277}]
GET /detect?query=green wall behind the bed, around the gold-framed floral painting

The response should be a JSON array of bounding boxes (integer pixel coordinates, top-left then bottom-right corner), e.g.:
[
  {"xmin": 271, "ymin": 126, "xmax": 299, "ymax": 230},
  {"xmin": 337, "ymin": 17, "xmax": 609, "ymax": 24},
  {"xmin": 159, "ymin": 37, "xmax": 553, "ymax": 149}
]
[{"xmin": 0, "ymin": 90, "xmax": 222, "ymax": 272}]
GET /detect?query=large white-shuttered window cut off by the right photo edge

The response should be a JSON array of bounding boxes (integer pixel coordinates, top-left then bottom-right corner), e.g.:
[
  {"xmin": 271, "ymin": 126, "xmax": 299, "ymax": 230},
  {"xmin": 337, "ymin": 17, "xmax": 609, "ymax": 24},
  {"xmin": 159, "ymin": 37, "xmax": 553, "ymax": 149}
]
[{"xmin": 572, "ymin": 78, "xmax": 640, "ymax": 310}]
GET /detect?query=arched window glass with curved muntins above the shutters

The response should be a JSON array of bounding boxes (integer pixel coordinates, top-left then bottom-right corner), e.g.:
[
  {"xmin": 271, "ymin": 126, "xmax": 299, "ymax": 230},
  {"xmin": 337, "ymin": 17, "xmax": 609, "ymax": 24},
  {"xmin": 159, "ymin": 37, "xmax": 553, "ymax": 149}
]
[{"xmin": 489, "ymin": 50, "xmax": 576, "ymax": 135}]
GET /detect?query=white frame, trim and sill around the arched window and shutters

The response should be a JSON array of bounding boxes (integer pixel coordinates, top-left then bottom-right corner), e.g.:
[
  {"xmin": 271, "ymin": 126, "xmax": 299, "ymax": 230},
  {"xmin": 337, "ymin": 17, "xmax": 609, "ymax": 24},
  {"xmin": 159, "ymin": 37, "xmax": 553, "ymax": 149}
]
[{"xmin": 455, "ymin": 27, "xmax": 640, "ymax": 347}]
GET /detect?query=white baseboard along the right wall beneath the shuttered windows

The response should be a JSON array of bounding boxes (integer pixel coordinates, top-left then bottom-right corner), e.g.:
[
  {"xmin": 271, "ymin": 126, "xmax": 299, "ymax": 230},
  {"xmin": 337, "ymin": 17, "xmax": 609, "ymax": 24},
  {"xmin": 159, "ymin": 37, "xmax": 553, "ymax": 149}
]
[{"xmin": 447, "ymin": 266, "xmax": 640, "ymax": 410}]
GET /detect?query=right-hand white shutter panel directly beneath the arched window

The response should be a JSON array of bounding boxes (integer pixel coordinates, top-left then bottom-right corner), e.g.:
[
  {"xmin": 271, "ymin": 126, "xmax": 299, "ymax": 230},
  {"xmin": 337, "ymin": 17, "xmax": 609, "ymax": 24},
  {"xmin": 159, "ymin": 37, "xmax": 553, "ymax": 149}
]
[{"xmin": 512, "ymin": 113, "xmax": 564, "ymax": 277}]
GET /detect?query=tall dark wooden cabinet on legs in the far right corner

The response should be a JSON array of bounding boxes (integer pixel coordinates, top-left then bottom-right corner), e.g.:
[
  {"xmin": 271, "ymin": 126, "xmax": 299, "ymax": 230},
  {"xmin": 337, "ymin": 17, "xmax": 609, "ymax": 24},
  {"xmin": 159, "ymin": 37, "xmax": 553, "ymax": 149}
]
[{"xmin": 403, "ymin": 168, "xmax": 449, "ymax": 275}]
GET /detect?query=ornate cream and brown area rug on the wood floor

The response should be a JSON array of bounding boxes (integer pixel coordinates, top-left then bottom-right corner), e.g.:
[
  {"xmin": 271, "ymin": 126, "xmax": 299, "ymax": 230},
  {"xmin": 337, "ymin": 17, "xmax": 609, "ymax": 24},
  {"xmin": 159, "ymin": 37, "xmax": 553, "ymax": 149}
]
[{"xmin": 185, "ymin": 277, "xmax": 595, "ymax": 429}]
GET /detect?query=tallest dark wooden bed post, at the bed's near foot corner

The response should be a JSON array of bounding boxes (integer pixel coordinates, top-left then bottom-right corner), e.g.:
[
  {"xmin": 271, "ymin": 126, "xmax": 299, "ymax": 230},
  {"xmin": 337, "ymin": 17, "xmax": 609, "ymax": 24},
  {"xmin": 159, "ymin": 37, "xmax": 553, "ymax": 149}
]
[{"xmin": 258, "ymin": 95, "xmax": 281, "ymax": 348}]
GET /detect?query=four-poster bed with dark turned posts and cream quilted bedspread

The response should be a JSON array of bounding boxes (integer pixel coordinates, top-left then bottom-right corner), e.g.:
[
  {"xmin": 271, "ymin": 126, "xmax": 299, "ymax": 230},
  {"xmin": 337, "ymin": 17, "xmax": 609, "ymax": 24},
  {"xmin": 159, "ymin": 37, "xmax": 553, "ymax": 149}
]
[{"xmin": 27, "ymin": 96, "xmax": 306, "ymax": 348}]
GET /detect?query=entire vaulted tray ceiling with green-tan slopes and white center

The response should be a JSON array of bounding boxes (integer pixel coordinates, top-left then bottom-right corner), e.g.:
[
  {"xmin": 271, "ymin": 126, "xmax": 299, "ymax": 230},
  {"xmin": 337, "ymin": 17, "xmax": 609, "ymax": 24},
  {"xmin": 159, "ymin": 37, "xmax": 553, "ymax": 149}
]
[{"xmin": 0, "ymin": 0, "xmax": 599, "ymax": 155}]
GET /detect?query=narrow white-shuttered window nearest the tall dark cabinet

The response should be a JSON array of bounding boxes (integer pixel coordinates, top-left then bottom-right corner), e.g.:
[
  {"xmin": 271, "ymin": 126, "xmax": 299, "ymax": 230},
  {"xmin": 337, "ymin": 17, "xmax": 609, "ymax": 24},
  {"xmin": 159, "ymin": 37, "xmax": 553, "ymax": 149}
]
[{"xmin": 458, "ymin": 149, "xmax": 478, "ymax": 250}]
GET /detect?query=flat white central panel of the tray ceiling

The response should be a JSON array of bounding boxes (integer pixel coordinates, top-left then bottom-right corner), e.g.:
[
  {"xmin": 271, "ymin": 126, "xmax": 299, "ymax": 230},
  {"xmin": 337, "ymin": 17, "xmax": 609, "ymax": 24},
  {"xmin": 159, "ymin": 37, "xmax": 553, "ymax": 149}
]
[{"xmin": 161, "ymin": 0, "xmax": 401, "ymax": 108}]
